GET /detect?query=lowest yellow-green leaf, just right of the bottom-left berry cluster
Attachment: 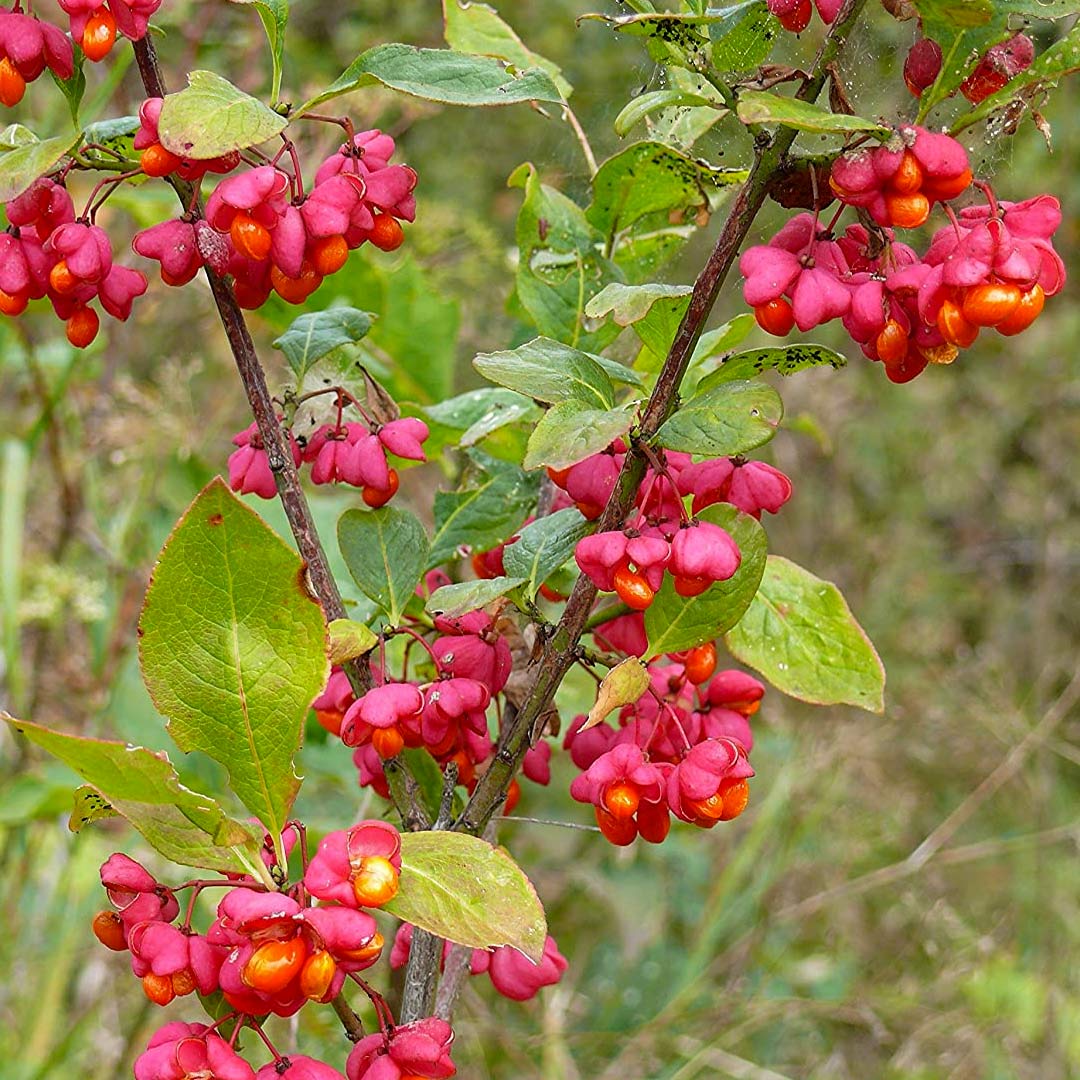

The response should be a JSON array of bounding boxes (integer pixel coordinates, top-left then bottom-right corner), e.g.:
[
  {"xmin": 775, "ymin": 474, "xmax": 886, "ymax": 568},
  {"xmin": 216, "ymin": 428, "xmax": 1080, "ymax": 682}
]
[{"xmin": 383, "ymin": 833, "xmax": 548, "ymax": 963}]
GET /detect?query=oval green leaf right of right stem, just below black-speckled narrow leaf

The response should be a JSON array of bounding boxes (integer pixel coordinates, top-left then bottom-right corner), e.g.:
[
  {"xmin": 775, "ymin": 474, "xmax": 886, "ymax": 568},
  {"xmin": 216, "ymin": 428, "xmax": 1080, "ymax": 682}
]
[{"xmin": 657, "ymin": 382, "xmax": 784, "ymax": 458}]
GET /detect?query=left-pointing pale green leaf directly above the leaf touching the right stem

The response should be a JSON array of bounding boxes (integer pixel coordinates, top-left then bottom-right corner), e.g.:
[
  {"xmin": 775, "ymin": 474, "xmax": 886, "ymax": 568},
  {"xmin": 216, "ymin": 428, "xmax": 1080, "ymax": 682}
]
[{"xmin": 473, "ymin": 337, "xmax": 615, "ymax": 408}]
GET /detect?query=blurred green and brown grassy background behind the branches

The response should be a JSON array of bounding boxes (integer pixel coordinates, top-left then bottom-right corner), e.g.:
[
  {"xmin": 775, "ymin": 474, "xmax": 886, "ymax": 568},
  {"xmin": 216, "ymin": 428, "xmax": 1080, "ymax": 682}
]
[{"xmin": 0, "ymin": 0, "xmax": 1080, "ymax": 1080}]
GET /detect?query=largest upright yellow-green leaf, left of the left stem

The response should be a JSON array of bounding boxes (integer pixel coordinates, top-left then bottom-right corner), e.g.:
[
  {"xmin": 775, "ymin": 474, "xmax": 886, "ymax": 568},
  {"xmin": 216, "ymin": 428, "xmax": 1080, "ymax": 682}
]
[{"xmin": 139, "ymin": 477, "xmax": 329, "ymax": 834}]
